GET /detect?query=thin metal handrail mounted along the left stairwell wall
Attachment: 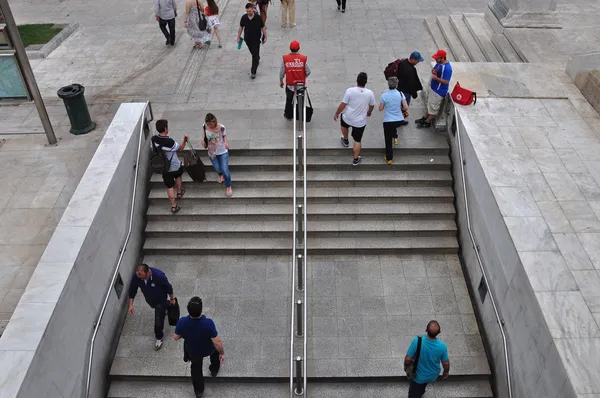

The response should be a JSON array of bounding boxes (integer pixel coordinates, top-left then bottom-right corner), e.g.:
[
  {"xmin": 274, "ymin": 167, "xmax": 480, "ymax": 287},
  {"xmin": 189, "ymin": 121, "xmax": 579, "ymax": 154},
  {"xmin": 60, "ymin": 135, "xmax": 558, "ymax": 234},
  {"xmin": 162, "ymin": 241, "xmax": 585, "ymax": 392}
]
[{"xmin": 84, "ymin": 101, "xmax": 154, "ymax": 398}]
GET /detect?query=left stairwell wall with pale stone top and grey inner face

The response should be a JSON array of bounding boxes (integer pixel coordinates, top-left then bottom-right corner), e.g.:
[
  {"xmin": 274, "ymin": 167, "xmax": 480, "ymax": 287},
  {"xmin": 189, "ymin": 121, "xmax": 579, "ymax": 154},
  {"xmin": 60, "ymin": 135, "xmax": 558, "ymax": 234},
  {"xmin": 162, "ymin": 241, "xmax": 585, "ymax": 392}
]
[{"xmin": 0, "ymin": 104, "xmax": 151, "ymax": 398}]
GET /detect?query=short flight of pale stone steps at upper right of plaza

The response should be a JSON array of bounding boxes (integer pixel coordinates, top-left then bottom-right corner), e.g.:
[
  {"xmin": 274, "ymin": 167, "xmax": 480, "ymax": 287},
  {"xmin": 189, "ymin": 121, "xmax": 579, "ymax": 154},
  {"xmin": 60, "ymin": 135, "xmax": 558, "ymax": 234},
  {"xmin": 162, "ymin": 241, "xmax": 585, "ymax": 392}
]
[{"xmin": 425, "ymin": 13, "xmax": 527, "ymax": 62}]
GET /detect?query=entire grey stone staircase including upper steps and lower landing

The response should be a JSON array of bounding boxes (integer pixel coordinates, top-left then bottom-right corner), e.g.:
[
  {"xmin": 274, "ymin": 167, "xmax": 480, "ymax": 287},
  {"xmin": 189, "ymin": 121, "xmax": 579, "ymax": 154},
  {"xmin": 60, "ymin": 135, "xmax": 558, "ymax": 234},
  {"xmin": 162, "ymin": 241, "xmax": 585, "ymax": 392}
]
[{"xmin": 108, "ymin": 137, "xmax": 493, "ymax": 398}]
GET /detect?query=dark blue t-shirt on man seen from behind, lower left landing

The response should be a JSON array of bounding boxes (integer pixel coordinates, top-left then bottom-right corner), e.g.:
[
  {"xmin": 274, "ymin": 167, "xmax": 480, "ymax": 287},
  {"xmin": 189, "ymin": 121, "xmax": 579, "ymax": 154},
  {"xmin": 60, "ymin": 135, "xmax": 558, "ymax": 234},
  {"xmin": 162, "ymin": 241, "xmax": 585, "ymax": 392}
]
[{"xmin": 175, "ymin": 315, "xmax": 218, "ymax": 358}]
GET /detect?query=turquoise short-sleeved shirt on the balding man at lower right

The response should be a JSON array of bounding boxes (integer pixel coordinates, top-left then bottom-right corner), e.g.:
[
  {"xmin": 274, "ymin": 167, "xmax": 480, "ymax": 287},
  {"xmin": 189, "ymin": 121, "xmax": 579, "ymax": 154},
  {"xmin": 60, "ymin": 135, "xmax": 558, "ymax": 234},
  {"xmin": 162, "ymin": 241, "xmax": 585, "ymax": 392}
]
[{"xmin": 406, "ymin": 335, "xmax": 448, "ymax": 384}]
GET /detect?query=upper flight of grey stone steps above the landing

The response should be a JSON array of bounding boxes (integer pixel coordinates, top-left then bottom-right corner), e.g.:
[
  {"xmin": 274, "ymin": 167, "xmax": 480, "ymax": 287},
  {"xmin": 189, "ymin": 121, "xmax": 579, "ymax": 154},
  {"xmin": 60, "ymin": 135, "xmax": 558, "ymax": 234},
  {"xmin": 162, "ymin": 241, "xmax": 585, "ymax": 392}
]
[{"xmin": 144, "ymin": 145, "xmax": 458, "ymax": 255}]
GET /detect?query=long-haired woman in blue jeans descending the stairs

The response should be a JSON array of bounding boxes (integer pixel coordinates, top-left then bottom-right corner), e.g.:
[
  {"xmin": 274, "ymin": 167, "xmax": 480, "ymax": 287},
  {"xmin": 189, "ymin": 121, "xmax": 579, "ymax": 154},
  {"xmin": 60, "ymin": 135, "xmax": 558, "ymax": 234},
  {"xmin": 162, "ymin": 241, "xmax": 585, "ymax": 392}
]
[{"xmin": 202, "ymin": 113, "xmax": 232, "ymax": 196}]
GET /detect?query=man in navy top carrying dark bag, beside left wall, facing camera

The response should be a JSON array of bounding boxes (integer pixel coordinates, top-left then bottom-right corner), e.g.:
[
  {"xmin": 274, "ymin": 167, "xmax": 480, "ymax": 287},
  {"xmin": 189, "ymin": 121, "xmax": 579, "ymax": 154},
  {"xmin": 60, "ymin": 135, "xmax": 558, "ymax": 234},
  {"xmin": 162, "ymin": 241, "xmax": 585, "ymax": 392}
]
[{"xmin": 129, "ymin": 264, "xmax": 175, "ymax": 350}]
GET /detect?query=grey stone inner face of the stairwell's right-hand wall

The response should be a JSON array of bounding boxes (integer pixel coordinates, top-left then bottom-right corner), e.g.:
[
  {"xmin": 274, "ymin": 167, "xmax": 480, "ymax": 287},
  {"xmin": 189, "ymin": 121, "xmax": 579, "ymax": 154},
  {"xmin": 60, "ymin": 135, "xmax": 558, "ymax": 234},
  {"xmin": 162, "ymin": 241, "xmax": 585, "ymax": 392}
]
[{"xmin": 442, "ymin": 109, "xmax": 576, "ymax": 398}]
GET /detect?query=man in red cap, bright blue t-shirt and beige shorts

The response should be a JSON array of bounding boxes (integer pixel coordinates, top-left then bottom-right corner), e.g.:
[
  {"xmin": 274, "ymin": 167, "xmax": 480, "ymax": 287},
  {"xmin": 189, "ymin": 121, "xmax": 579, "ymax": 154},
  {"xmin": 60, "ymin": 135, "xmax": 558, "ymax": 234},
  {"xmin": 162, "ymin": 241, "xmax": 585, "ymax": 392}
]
[{"xmin": 415, "ymin": 50, "xmax": 452, "ymax": 128}]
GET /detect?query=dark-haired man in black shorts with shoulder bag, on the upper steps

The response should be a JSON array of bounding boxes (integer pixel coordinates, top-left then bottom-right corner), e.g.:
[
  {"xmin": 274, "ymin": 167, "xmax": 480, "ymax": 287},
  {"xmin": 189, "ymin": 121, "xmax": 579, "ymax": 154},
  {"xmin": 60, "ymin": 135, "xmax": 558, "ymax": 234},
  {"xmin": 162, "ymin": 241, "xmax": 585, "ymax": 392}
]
[{"xmin": 152, "ymin": 119, "xmax": 189, "ymax": 213}]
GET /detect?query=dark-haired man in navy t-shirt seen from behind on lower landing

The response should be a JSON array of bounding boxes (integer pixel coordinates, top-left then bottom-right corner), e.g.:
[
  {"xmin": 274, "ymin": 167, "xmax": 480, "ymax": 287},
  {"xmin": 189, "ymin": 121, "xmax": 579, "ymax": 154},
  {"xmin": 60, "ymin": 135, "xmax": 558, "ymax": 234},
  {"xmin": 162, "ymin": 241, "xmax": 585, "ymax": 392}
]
[{"xmin": 173, "ymin": 296, "xmax": 225, "ymax": 398}]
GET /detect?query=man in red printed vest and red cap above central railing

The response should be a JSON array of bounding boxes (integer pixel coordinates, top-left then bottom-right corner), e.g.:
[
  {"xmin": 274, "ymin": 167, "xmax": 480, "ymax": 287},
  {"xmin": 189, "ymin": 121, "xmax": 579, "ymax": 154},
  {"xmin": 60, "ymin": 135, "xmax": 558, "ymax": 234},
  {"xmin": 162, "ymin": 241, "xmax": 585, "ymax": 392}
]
[{"xmin": 279, "ymin": 40, "xmax": 310, "ymax": 120}]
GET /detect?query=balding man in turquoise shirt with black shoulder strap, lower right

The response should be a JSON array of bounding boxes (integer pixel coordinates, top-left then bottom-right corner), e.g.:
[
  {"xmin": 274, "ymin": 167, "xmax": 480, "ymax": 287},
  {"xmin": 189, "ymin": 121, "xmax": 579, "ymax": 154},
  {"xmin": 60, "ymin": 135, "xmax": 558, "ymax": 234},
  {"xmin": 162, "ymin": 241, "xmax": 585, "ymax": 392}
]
[{"xmin": 404, "ymin": 321, "xmax": 450, "ymax": 398}]
